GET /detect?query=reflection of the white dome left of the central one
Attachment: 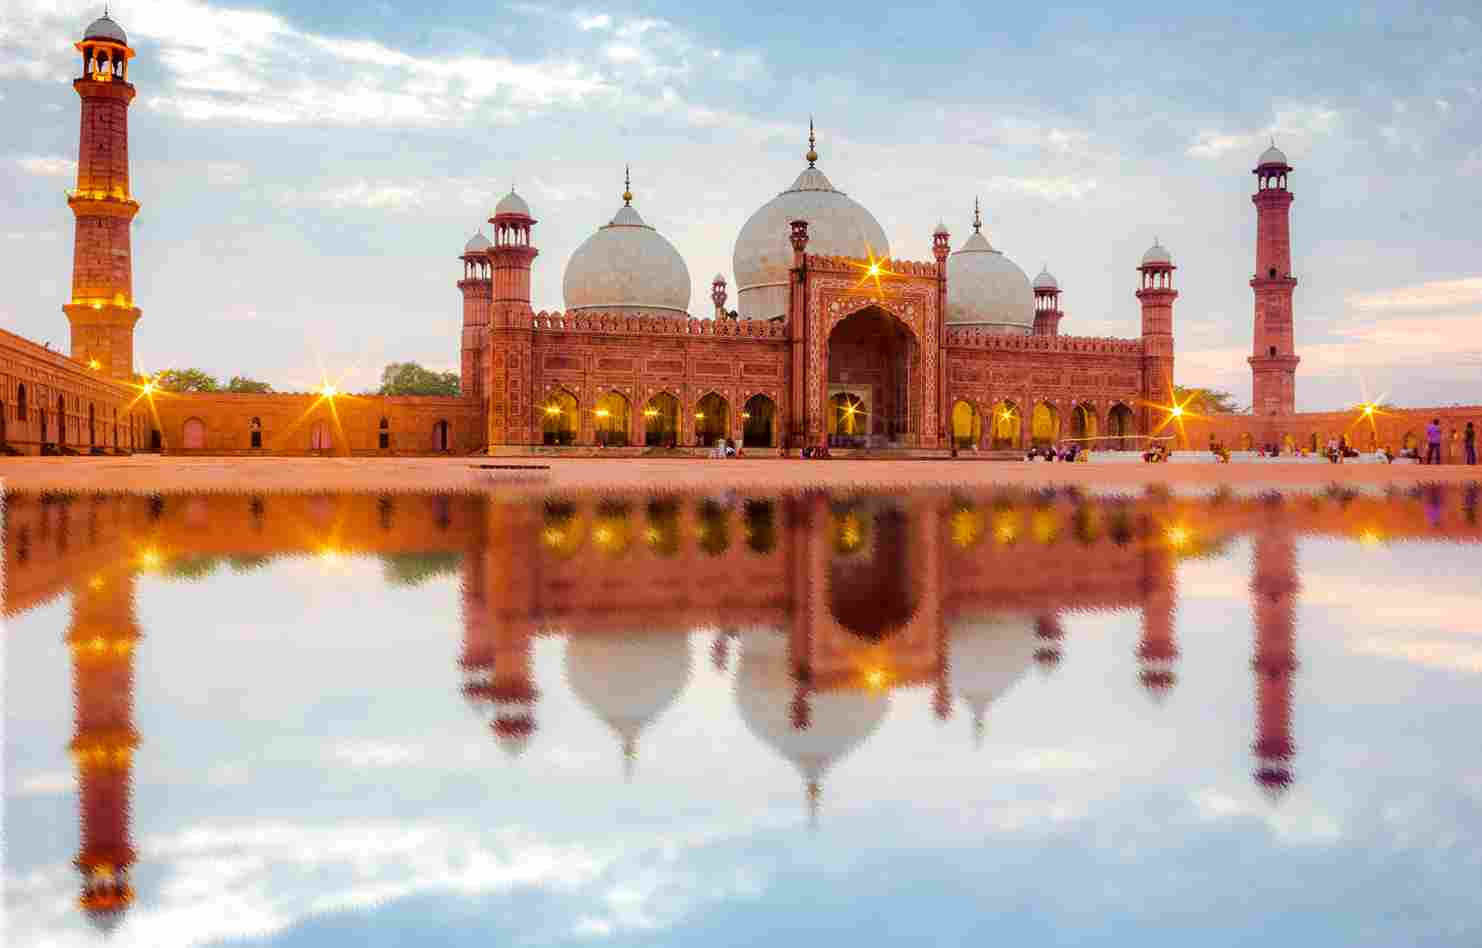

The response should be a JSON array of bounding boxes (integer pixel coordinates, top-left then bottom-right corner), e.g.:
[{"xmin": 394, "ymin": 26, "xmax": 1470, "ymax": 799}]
[{"xmin": 566, "ymin": 631, "xmax": 692, "ymax": 776}]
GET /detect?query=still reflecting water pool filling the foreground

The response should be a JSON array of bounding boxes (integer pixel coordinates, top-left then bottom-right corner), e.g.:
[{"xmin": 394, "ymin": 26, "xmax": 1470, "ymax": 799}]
[{"xmin": 4, "ymin": 484, "xmax": 1482, "ymax": 948}]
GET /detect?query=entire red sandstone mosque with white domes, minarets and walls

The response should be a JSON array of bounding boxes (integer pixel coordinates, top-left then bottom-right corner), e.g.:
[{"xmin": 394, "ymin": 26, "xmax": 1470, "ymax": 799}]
[{"xmin": 0, "ymin": 15, "xmax": 1482, "ymax": 459}]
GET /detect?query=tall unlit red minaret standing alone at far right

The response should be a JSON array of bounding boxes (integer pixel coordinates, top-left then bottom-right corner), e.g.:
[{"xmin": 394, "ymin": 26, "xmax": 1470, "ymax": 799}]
[{"xmin": 1246, "ymin": 141, "xmax": 1301, "ymax": 415}]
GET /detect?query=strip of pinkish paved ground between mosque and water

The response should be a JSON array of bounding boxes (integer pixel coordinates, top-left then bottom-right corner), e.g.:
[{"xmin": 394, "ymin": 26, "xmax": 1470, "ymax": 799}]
[{"xmin": 0, "ymin": 456, "xmax": 1482, "ymax": 492}]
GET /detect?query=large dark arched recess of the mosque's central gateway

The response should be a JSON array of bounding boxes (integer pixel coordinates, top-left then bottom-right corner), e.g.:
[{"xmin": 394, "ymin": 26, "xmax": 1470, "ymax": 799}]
[{"xmin": 824, "ymin": 307, "xmax": 922, "ymax": 447}]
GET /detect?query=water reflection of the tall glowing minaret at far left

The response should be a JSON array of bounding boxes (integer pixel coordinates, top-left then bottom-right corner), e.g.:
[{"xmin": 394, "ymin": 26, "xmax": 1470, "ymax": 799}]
[{"xmin": 67, "ymin": 575, "xmax": 139, "ymax": 932}]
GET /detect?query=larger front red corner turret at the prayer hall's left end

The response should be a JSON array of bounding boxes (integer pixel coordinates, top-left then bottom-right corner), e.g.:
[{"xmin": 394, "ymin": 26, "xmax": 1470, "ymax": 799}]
[{"xmin": 483, "ymin": 188, "xmax": 539, "ymax": 452}]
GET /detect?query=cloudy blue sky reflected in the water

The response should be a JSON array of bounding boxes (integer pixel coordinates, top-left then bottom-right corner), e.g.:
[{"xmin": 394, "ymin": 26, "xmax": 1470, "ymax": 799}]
[{"xmin": 4, "ymin": 539, "xmax": 1482, "ymax": 948}]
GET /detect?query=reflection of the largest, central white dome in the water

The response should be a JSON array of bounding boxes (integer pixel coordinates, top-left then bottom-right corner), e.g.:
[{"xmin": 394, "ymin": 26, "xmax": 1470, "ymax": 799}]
[{"xmin": 737, "ymin": 630, "xmax": 889, "ymax": 809}]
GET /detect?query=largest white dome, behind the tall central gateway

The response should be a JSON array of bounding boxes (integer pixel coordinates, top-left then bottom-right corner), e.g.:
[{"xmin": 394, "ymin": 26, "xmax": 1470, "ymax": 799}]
[{"xmin": 731, "ymin": 127, "xmax": 891, "ymax": 320}]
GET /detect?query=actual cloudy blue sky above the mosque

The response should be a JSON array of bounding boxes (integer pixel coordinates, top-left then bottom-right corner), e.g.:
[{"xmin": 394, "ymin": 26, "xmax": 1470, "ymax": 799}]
[{"xmin": 0, "ymin": 0, "xmax": 1482, "ymax": 410}]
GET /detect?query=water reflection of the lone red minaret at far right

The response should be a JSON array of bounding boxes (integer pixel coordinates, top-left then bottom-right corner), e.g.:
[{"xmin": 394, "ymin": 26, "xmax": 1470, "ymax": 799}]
[{"xmin": 1251, "ymin": 527, "xmax": 1298, "ymax": 798}]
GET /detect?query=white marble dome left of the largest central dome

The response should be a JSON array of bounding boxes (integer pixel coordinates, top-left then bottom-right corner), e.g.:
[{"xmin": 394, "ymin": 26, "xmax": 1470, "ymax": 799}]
[{"xmin": 562, "ymin": 195, "xmax": 691, "ymax": 316}]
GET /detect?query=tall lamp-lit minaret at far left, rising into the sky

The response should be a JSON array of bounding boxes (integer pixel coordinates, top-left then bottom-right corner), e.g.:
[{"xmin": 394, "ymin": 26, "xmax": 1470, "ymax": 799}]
[{"xmin": 62, "ymin": 13, "xmax": 141, "ymax": 381}]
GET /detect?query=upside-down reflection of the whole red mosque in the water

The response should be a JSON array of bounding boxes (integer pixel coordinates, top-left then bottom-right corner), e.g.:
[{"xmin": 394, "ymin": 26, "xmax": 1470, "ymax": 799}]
[{"xmin": 4, "ymin": 487, "xmax": 1482, "ymax": 927}]
